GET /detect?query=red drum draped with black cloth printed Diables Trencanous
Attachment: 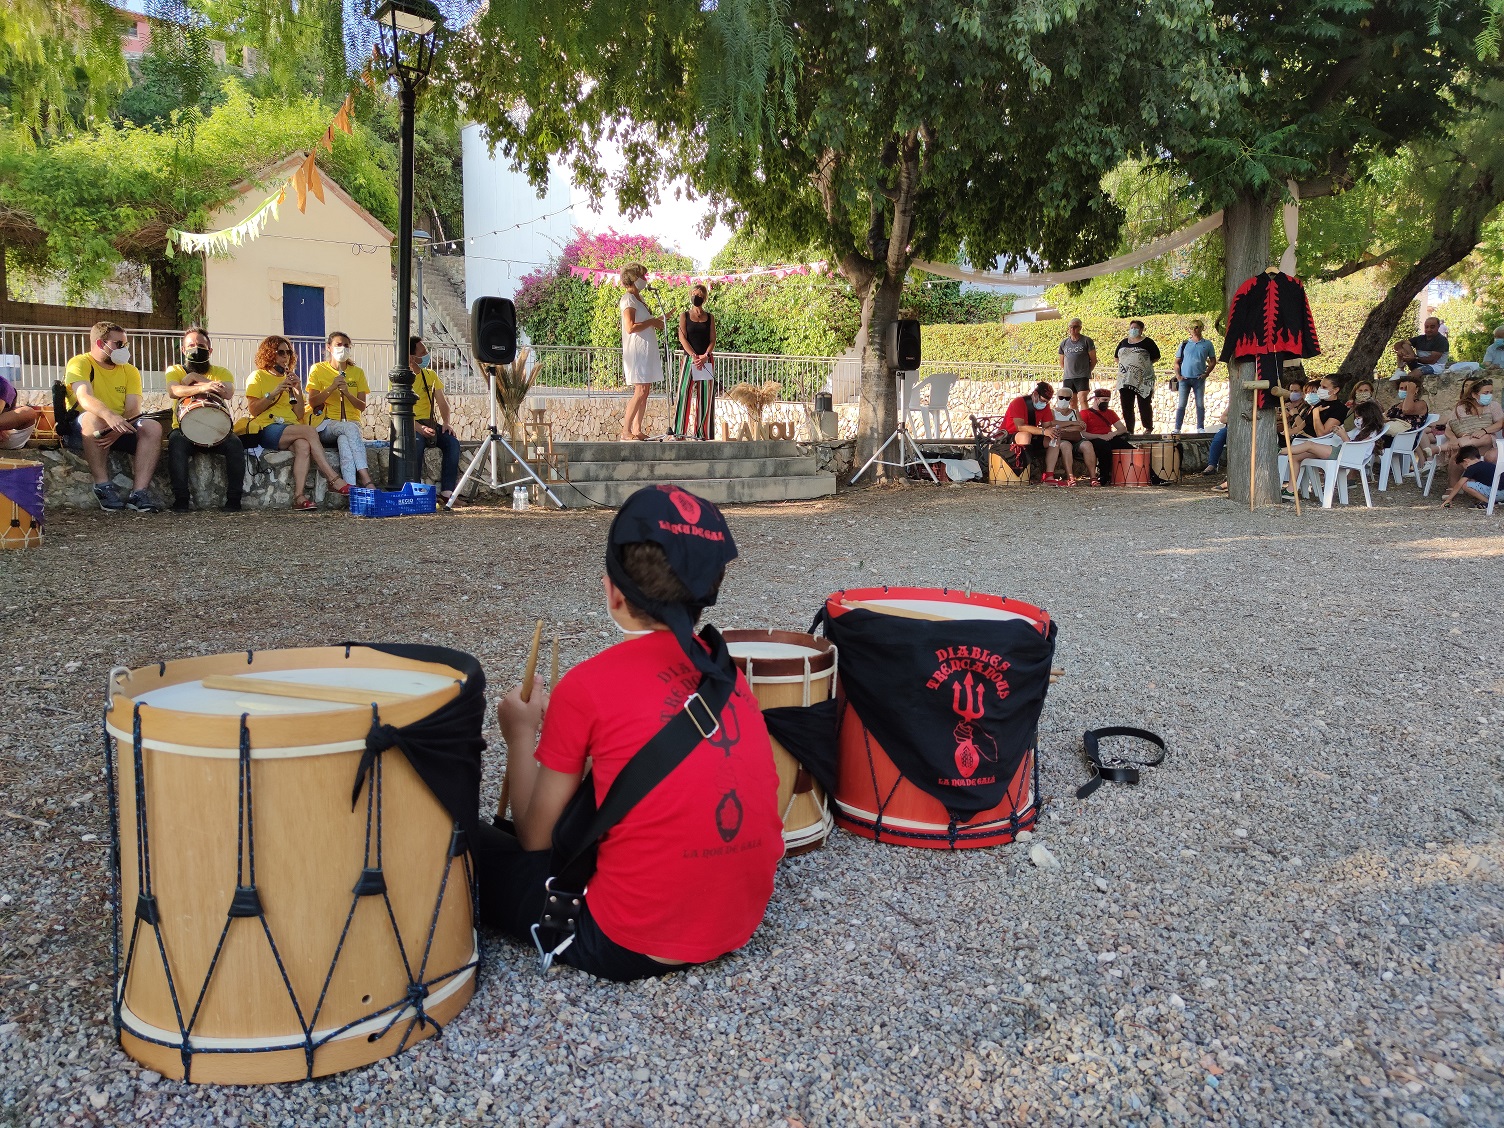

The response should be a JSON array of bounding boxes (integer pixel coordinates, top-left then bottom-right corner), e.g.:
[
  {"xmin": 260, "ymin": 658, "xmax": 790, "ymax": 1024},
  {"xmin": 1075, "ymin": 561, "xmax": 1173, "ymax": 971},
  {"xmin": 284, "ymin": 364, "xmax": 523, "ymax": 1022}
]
[{"xmin": 821, "ymin": 588, "xmax": 1056, "ymax": 850}]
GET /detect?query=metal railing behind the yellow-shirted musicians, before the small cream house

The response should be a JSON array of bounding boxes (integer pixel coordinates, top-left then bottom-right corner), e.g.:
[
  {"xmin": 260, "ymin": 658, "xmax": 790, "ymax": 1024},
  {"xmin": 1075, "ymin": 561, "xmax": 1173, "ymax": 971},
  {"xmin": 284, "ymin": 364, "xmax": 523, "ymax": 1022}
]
[{"xmin": 0, "ymin": 325, "xmax": 486, "ymax": 396}]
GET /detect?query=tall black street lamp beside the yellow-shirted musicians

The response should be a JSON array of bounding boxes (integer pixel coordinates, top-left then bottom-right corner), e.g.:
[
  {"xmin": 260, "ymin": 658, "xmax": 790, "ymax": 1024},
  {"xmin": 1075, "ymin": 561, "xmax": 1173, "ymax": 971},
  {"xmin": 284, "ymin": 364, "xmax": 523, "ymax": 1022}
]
[{"xmin": 371, "ymin": 0, "xmax": 444, "ymax": 489}]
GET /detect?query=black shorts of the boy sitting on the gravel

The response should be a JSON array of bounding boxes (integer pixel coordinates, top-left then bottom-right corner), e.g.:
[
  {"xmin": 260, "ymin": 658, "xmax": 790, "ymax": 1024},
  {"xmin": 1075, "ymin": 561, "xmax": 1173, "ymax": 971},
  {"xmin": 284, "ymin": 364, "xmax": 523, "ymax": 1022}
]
[{"xmin": 471, "ymin": 823, "xmax": 687, "ymax": 984}]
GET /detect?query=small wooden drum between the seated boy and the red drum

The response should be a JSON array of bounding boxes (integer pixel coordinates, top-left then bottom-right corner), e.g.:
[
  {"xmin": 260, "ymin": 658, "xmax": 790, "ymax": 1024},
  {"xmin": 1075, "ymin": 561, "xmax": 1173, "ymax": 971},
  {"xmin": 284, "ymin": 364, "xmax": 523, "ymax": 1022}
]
[{"xmin": 722, "ymin": 630, "xmax": 836, "ymax": 854}]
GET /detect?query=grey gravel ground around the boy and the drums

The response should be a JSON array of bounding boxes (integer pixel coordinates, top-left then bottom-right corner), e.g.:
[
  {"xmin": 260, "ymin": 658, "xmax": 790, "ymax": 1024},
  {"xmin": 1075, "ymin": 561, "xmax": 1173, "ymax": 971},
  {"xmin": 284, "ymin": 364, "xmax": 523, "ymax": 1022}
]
[{"xmin": 0, "ymin": 486, "xmax": 1504, "ymax": 1128}]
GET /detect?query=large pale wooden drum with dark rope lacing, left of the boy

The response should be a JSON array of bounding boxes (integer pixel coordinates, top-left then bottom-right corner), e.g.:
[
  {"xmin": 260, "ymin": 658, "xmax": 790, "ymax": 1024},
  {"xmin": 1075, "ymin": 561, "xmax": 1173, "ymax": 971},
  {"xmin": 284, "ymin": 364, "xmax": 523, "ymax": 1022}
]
[{"xmin": 105, "ymin": 647, "xmax": 478, "ymax": 1084}]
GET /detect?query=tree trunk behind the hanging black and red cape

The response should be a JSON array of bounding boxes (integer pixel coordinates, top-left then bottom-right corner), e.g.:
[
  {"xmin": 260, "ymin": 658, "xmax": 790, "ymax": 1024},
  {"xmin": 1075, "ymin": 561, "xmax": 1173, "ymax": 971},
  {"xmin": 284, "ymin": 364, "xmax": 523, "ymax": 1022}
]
[{"xmin": 1223, "ymin": 196, "xmax": 1280, "ymax": 508}]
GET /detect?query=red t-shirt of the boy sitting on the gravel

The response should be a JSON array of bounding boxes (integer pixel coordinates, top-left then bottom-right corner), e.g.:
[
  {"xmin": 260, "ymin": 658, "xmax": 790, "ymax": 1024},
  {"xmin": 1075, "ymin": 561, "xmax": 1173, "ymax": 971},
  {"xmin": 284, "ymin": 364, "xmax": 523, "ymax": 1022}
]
[{"xmin": 535, "ymin": 630, "xmax": 784, "ymax": 963}]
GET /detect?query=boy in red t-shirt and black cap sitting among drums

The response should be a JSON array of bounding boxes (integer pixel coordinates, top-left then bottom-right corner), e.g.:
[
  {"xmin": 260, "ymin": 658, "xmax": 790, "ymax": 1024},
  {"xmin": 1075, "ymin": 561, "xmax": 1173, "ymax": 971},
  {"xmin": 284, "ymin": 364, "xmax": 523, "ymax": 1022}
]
[{"xmin": 475, "ymin": 486, "xmax": 784, "ymax": 981}]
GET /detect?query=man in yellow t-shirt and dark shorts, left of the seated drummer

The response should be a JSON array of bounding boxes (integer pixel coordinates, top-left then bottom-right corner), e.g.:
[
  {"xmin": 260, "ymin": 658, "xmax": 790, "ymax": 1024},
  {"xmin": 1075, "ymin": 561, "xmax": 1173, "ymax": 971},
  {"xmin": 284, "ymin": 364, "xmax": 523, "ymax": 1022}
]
[{"xmin": 63, "ymin": 322, "xmax": 162, "ymax": 513}]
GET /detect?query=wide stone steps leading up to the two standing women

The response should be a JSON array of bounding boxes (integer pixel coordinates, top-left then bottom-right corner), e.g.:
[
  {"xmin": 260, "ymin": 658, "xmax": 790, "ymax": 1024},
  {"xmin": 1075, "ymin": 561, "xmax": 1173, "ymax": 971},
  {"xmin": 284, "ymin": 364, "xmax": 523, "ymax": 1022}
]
[{"xmin": 553, "ymin": 442, "xmax": 836, "ymax": 508}]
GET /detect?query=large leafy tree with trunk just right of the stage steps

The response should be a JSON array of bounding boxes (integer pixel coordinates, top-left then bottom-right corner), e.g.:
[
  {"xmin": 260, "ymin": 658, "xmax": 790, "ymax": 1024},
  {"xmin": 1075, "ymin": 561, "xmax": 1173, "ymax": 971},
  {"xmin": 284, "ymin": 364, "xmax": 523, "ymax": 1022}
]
[{"xmin": 450, "ymin": 0, "xmax": 1215, "ymax": 469}]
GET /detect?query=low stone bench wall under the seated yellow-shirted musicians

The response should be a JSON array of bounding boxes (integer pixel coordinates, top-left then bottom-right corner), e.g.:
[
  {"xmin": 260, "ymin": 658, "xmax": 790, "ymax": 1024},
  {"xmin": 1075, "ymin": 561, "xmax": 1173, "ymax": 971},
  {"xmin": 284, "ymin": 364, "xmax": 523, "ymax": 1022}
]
[{"xmin": 25, "ymin": 441, "xmax": 493, "ymax": 510}]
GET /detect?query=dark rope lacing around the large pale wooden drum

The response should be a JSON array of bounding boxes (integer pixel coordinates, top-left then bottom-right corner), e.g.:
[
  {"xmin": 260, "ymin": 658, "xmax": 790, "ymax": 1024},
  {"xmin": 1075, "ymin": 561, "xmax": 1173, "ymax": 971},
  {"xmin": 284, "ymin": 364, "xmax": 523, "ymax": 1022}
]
[{"xmin": 102, "ymin": 676, "xmax": 480, "ymax": 1081}]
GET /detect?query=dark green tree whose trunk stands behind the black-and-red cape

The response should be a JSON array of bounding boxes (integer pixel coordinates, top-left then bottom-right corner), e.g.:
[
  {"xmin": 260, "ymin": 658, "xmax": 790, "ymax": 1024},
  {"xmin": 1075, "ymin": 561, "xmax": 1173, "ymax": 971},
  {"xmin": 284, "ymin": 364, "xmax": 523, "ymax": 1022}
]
[{"xmin": 1160, "ymin": 0, "xmax": 1481, "ymax": 504}]
